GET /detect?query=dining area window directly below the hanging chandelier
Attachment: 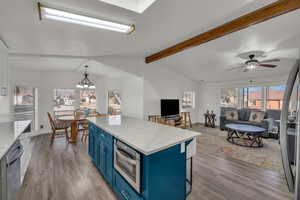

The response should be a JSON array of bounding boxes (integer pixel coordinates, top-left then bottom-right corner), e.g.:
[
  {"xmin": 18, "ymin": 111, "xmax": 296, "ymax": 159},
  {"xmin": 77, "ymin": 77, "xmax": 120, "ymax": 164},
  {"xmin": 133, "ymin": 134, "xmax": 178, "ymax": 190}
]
[{"xmin": 80, "ymin": 90, "xmax": 96, "ymax": 110}]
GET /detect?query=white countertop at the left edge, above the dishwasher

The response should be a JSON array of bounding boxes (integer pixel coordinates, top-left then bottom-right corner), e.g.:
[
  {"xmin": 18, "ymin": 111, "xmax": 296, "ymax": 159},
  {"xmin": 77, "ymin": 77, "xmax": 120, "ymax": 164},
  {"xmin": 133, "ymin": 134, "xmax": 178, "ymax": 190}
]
[{"xmin": 0, "ymin": 120, "xmax": 31, "ymax": 159}]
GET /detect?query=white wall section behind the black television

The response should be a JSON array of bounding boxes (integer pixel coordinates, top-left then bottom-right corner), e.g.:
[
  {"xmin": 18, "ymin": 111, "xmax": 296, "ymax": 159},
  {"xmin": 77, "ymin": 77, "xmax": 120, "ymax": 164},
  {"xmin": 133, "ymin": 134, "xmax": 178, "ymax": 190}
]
[{"xmin": 144, "ymin": 63, "xmax": 199, "ymax": 123}]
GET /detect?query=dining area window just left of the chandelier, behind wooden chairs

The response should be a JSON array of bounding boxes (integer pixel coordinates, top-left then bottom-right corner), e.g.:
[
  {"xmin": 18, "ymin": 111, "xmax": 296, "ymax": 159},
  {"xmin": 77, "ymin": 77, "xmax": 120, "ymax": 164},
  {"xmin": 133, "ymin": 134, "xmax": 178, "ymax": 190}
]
[{"xmin": 54, "ymin": 89, "xmax": 75, "ymax": 118}]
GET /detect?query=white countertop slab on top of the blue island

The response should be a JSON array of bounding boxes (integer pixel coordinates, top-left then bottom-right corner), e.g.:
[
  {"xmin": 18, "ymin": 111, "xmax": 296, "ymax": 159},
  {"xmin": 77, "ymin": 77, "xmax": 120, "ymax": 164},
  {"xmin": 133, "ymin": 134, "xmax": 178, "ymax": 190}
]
[{"xmin": 88, "ymin": 116, "xmax": 201, "ymax": 155}]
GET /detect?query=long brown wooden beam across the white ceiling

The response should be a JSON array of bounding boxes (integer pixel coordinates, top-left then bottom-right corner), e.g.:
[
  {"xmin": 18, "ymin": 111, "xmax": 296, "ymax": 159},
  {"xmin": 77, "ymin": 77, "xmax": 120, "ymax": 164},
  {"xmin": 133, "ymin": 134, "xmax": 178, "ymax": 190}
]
[{"xmin": 145, "ymin": 0, "xmax": 300, "ymax": 63}]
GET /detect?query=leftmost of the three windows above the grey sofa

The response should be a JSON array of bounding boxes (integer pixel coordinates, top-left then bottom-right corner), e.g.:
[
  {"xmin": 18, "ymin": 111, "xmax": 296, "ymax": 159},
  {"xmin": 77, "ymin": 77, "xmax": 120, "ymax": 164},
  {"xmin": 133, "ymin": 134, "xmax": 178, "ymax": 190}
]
[{"xmin": 221, "ymin": 88, "xmax": 238, "ymax": 107}]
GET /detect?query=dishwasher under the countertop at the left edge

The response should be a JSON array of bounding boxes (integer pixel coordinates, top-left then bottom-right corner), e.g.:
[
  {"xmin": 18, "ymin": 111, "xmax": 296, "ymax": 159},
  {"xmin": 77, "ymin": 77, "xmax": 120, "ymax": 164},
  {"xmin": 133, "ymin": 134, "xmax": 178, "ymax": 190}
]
[{"xmin": 0, "ymin": 140, "xmax": 24, "ymax": 200}]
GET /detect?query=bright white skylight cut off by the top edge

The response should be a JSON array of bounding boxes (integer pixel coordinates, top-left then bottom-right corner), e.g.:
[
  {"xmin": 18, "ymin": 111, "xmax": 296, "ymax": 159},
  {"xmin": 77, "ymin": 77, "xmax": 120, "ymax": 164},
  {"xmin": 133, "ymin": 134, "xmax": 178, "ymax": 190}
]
[{"xmin": 99, "ymin": 0, "xmax": 156, "ymax": 13}]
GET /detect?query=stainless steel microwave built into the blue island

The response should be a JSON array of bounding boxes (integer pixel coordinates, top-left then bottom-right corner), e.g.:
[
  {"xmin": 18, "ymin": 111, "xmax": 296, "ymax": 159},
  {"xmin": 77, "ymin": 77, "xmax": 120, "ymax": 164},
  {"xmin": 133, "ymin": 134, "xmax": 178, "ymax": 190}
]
[{"xmin": 114, "ymin": 139, "xmax": 141, "ymax": 193}]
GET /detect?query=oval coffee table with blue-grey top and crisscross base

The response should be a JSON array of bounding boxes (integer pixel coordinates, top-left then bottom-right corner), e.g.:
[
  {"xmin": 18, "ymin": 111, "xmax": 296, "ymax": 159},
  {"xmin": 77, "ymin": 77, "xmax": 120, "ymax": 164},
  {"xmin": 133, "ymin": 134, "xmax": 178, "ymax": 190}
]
[{"xmin": 225, "ymin": 124, "xmax": 266, "ymax": 148}]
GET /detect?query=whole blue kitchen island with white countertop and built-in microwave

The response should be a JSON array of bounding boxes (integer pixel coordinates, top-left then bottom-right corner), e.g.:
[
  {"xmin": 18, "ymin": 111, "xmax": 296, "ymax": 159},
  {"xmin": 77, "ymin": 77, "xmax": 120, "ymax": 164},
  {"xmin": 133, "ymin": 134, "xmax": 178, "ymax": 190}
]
[{"xmin": 89, "ymin": 116, "xmax": 200, "ymax": 200}]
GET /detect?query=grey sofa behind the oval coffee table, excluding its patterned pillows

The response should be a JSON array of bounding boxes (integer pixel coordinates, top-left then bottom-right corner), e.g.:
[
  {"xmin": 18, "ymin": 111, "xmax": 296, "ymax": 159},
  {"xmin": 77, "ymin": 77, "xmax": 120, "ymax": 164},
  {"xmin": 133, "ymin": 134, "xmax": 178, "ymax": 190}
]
[{"xmin": 220, "ymin": 107, "xmax": 281, "ymax": 137}]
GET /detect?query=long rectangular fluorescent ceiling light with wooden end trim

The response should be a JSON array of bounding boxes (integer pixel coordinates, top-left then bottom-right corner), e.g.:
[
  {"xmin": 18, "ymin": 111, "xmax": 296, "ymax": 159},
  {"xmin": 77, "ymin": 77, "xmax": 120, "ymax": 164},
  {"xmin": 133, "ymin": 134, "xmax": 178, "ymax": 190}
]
[{"xmin": 38, "ymin": 3, "xmax": 135, "ymax": 34}]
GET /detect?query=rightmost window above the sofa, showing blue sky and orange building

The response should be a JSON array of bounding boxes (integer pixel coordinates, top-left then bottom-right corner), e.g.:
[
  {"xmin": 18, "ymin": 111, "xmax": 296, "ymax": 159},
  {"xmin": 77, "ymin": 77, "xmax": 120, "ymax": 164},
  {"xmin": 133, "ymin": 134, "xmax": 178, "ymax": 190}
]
[{"xmin": 267, "ymin": 85, "xmax": 285, "ymax": 110}]
